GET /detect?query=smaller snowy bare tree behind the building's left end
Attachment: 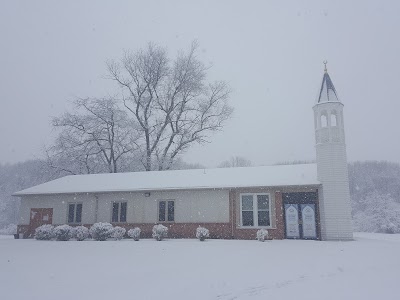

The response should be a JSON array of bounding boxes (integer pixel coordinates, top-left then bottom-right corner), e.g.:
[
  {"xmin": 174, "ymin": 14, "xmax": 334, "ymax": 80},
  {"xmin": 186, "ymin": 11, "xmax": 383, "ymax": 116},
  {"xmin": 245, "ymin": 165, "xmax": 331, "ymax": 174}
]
[{"xmin": 46, "ymin": 98, "xmax": 137, "ymax": 174}]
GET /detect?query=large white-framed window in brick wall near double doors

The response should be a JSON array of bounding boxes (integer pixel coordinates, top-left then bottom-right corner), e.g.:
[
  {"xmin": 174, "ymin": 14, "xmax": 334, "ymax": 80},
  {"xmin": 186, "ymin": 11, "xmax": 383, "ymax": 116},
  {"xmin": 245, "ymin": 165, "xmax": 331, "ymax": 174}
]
[{"xmin": 240, "ymin": 194, "xmax": 271, "ymax": 227}]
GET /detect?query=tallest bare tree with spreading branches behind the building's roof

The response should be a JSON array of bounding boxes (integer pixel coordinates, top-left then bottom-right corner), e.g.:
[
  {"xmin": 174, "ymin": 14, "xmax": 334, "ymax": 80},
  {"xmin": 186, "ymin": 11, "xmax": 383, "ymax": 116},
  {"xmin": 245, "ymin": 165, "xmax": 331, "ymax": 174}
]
[{"xmin": 107, "ymin": 42, "xmax": 233, "ymax": 171}]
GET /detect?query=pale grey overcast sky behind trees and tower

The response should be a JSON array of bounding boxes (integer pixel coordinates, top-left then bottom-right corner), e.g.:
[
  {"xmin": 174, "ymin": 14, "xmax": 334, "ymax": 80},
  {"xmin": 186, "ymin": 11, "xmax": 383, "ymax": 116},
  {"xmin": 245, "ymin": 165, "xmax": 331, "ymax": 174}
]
[{"xmin": 0, "ymin": 0, "xmax": 400, "ymax": 167}]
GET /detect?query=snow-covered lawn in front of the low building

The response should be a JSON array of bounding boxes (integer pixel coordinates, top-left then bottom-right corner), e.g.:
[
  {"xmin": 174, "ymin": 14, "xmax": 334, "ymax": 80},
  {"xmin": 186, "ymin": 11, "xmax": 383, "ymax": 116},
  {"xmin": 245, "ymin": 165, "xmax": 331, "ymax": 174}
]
[{"xmin": 0, "ymin": 233, "xmax": 400, "ymax": 300}]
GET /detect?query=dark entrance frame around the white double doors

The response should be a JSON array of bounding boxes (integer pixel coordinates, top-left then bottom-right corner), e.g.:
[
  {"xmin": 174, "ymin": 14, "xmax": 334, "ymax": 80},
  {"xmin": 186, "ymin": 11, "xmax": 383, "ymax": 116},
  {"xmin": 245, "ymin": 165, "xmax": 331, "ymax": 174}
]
[{"xmin": 282, "ymin": 190, "xmax": 321, "ymax": 240}]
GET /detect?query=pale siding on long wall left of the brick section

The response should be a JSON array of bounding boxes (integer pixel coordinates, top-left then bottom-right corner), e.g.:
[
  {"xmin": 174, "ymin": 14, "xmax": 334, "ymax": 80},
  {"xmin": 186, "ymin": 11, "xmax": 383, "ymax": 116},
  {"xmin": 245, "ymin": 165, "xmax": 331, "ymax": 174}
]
[{"xmin": 20, "ymin": 190, "xmax": 229, "ymax": 225}]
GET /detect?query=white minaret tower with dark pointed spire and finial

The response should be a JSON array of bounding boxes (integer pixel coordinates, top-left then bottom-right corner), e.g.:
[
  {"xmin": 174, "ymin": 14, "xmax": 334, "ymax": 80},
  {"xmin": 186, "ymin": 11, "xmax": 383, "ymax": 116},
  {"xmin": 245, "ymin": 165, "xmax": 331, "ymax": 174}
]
[{"xmin": 313, "ymin": 62, "xmax": 353, "ymax": 240}]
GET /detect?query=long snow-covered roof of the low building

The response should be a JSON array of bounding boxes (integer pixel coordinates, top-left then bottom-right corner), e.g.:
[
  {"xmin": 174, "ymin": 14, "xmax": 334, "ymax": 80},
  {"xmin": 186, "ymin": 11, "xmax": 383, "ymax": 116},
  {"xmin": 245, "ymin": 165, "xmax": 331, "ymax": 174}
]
[{"xmin": 14, "ymin": 164, "xmax": 320, "ymax": 196}]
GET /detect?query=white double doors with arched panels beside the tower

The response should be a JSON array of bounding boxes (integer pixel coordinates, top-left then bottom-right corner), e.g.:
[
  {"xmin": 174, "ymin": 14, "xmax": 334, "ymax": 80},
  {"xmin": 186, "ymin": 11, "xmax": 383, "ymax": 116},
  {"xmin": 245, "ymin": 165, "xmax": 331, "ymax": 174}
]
[{"xmin": 285, "ymin": 203, "xmax": 317, "ymax": 239}]
